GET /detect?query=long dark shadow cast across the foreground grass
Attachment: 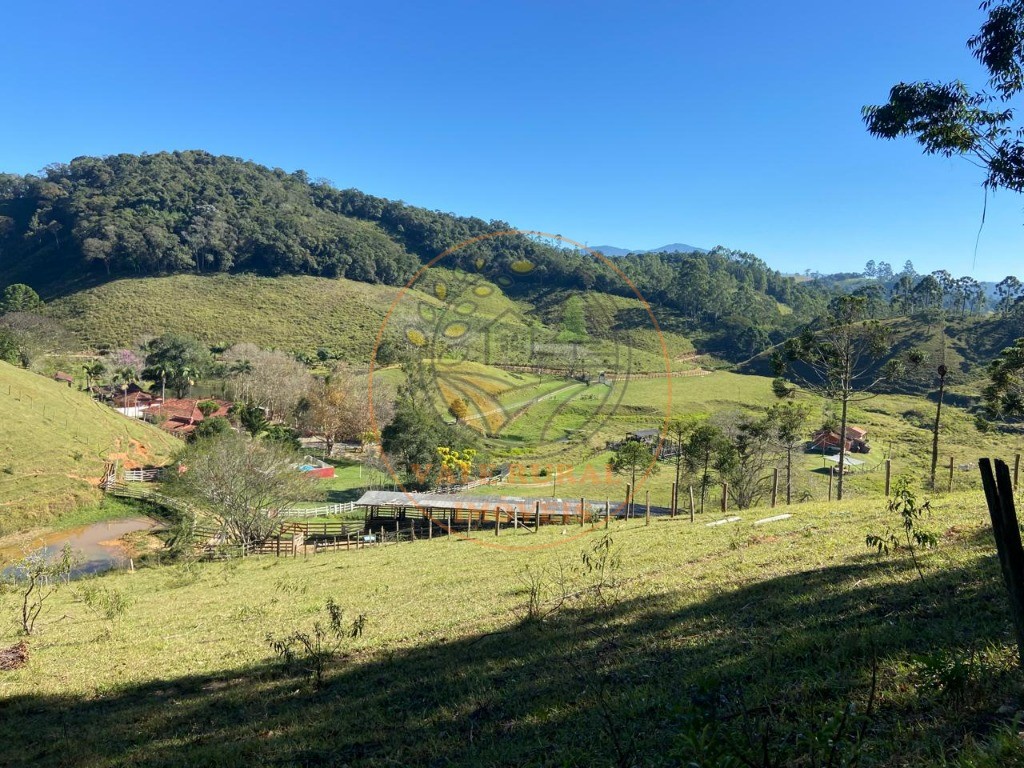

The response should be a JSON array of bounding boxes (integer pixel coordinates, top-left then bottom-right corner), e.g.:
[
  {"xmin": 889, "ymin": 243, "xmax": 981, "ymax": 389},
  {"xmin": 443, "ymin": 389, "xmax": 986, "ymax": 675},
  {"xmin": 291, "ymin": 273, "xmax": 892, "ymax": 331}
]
[{"xmin": 0, "ymin": 556, "xmax": 1020, "ymax": 766}]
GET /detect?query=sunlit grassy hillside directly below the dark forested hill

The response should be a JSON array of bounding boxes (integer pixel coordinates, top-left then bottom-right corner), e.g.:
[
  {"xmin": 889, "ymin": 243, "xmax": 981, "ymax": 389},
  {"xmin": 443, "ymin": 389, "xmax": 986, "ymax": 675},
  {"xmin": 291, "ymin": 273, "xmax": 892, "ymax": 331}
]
[{"xmin": 46, "ymin": 267, "xmax": 693, "ymax": 370}]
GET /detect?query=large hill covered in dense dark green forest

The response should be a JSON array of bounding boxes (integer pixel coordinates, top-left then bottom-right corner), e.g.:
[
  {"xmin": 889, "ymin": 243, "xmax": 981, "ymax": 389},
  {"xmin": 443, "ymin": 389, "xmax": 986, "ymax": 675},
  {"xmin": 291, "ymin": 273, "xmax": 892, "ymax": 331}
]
[{"xmin": 0, "ymin": 151, "xmax": 824, "ymax": 346}]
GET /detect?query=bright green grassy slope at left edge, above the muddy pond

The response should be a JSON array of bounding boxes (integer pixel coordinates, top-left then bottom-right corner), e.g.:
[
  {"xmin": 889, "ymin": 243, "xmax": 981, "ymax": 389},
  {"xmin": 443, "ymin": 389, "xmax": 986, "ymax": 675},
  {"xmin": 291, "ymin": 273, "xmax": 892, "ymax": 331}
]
[{"xmin": 0, "ymin": 362, "xmax": 180, "ymax": 532}]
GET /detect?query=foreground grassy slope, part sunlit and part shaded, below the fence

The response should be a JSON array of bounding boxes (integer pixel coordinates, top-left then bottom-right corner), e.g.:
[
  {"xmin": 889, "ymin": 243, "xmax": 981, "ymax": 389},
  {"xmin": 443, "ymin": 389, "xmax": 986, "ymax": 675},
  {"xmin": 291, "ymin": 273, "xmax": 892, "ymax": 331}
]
[{"xmin": 0, "ymin": 494, "xmax": 1022, "ymax": 767}]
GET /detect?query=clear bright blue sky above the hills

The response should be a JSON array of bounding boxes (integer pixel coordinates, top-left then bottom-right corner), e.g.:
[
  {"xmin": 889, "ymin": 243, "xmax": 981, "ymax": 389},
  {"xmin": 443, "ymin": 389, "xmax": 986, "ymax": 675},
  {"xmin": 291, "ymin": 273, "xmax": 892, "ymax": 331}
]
[{"xmin": 0, "ymin": 0, "xmax": 1024, "ymax": 280}]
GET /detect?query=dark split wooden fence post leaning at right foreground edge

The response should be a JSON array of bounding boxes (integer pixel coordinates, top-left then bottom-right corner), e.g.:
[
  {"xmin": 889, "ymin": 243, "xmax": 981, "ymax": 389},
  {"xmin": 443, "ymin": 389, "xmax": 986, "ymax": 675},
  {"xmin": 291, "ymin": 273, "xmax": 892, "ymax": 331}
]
[{"xmin": 978, "ymin": 459, "xmax": 1024, "ymax": 667}]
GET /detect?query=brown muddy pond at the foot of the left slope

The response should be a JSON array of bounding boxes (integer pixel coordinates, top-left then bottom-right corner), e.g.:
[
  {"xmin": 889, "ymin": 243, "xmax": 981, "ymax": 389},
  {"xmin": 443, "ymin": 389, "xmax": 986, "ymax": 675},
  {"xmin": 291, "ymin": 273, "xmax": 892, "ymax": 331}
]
[{"xmin": 0, "ymin": 517, "xmax": 157, "ymax": 578}]
